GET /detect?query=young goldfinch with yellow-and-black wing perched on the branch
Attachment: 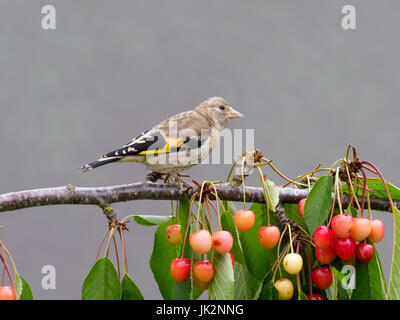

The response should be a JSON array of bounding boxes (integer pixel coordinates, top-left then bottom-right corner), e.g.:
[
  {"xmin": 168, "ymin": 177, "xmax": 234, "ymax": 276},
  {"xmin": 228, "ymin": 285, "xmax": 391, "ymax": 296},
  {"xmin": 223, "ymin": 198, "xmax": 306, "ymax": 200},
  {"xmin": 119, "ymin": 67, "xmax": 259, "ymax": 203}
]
[{"xmin": 82, "ymin": 97, "xmax": 243, "ymax": 175}]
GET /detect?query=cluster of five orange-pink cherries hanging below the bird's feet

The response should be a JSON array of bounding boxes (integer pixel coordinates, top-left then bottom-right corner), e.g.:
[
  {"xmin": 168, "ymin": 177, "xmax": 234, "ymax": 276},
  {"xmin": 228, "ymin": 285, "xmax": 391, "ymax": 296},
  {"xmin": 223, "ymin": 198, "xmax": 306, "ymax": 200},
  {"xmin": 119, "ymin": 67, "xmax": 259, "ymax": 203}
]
[{"xmin": 166, "ymin": 224, "xmax": 234, "ymax": 290}]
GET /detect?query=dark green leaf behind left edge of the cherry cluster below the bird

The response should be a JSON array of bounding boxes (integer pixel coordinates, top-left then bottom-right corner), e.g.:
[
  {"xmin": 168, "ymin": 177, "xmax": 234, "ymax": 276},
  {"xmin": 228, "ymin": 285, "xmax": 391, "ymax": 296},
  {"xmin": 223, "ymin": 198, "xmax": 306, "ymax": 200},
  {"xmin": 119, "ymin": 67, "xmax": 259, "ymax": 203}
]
[{"xmin": 150, "ymin": 220, "xmax": 177, "ymax": 300}]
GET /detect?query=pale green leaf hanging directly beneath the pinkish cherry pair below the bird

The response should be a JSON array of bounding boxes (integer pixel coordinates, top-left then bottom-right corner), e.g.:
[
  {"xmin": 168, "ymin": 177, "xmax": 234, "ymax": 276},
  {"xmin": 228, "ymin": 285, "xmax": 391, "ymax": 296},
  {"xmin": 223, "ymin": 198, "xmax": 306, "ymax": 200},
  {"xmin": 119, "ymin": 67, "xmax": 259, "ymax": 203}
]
[{"xmin": 208, "ymin": 253, "xmax": 235, "ymax": 300}]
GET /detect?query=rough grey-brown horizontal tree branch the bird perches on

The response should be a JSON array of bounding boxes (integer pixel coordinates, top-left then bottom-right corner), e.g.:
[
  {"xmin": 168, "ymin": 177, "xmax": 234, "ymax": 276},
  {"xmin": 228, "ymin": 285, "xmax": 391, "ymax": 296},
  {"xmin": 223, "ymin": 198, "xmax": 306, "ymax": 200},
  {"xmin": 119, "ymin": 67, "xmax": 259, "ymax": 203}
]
[{"xmin": 0, "ymin": 182, "xmax": 400, "ymax": 212}]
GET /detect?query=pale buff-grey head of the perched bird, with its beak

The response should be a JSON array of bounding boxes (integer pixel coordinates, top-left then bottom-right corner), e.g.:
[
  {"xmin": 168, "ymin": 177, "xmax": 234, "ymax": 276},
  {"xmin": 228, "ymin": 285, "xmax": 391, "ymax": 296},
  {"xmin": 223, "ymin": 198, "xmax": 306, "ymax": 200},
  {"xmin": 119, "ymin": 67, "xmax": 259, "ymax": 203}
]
[{"xmin": 195, "ymin": 97, "xmax": 243, "ymax": 130}]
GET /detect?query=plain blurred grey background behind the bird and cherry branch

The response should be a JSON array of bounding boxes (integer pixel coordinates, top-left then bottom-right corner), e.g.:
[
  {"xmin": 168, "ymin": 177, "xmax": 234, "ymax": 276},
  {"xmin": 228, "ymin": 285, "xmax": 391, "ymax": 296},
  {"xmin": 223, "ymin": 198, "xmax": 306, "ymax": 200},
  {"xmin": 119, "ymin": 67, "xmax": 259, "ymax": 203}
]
[{"xmin": 0, "ymin": 0, "xmax": 400, "ymax": 299}]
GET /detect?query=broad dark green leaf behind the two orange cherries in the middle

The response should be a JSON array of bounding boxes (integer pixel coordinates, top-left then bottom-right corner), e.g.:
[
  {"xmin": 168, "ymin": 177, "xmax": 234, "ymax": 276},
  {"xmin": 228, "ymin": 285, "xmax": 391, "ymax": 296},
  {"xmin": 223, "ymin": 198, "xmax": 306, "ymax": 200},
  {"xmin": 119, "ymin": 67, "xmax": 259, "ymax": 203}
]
[{"xmin": 240, "ymin": 203, "xmax": 278, "ymax": 281}]
